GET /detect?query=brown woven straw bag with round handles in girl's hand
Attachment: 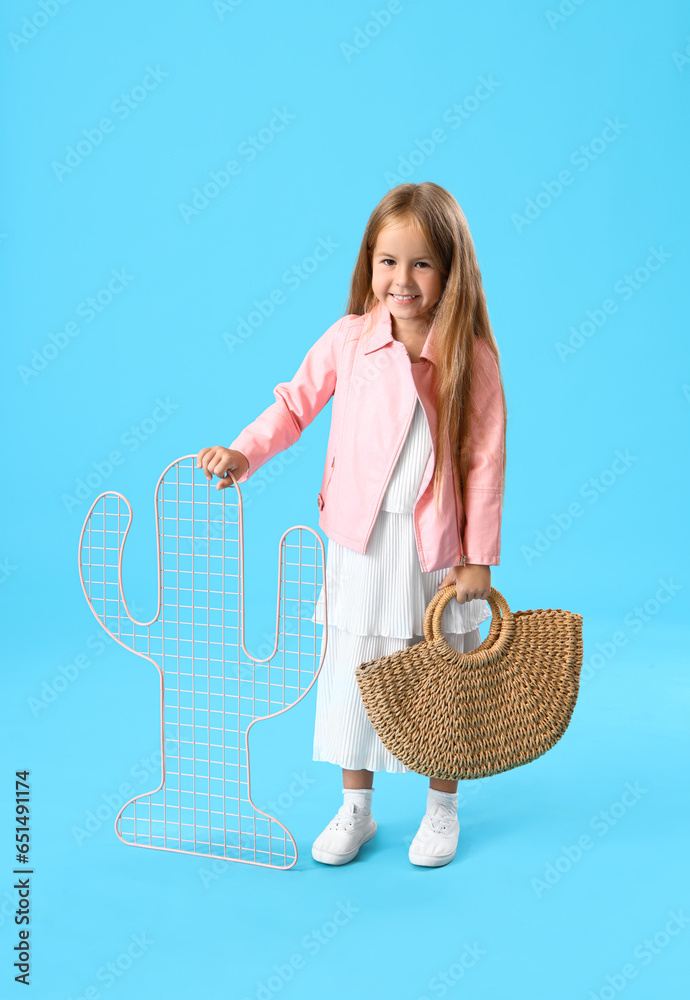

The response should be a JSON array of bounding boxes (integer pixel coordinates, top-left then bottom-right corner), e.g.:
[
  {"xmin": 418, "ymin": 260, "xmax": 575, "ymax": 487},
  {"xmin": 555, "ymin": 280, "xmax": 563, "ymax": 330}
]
[{"xmin": 356, "ymin": 584, "xmax": 582, "ymax": 779}]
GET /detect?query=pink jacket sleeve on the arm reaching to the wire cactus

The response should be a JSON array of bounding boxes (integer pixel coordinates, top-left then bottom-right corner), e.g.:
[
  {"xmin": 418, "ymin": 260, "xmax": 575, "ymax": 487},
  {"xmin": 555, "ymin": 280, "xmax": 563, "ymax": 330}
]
[{"xmin": 228, "ymin": 317, "xmax": 344, "ymax": 483}]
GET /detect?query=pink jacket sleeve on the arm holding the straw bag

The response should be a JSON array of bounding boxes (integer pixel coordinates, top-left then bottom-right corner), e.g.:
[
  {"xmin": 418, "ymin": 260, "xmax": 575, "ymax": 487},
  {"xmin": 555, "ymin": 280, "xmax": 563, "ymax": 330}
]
[{"xmin": 462, "ymin": 339, "xmax": 505, "ymax": 566}]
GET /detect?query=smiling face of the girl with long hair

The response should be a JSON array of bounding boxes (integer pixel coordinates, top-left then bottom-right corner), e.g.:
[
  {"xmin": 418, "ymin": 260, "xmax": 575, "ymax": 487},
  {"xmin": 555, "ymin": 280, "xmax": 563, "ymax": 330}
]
[{"xmin": 371, "ymin": 225, "xmax": 443, "ymax": 323}]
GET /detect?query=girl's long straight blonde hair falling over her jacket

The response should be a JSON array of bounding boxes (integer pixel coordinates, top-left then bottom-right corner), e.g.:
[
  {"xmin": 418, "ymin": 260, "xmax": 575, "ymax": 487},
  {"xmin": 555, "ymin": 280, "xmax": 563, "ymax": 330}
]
[{"xmin": 345, "ymin": 181, "xmax": 507, "ymax": 532}]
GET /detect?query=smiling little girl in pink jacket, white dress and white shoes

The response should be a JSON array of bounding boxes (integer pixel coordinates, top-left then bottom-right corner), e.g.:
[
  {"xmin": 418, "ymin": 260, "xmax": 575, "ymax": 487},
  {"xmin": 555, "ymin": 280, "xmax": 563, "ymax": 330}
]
[{"xmin": 197, "ymin": 182, "xmax": 506, "ymax": 867}]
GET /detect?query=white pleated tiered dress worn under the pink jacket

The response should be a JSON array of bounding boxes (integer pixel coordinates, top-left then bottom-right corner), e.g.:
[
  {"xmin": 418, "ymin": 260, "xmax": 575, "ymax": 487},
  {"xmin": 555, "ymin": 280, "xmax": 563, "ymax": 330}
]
[{"xmin": 312, "ymin": 397, "xmax": 491, "ymax": 772}]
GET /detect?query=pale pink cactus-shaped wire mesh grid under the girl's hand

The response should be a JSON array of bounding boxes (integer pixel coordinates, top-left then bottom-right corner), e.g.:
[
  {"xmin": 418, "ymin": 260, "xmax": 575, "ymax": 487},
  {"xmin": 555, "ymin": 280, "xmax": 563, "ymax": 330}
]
[{"xmin": 79, "ymin": 455, "xmax": 326, "ymax": 868}]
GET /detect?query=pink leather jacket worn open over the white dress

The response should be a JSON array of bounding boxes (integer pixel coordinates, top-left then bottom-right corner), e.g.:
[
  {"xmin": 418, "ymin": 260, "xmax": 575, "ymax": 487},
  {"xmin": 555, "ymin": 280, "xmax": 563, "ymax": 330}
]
[{"xmin": 228, "ymin": 302, "xmax": 505, "ymax": 572}]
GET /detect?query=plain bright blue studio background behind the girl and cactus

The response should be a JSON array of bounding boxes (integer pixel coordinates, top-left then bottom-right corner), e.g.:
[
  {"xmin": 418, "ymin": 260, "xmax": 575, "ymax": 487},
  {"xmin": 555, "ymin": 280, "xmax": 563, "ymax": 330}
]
[{"xmin": 0, "ymin": 0, "xmax": 690, "ymax": 1000}]
